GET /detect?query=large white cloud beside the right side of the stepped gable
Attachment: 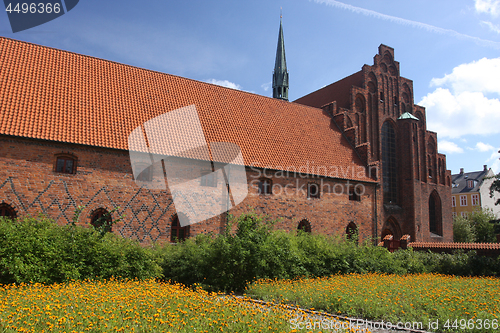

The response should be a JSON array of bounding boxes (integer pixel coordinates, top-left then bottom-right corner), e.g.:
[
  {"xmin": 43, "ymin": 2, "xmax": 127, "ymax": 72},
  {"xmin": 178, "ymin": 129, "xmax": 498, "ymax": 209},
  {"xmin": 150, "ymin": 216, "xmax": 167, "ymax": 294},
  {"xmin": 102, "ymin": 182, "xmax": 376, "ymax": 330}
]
[{"xmin": 418, "ymin": 58, "xmax": 500, "ymax": 138}]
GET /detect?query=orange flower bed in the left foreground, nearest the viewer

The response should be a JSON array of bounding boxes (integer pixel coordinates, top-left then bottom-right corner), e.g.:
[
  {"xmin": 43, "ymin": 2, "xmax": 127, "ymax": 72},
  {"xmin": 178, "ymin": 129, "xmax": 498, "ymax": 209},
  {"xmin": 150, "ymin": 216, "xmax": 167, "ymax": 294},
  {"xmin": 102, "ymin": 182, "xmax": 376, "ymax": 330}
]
[{"xmin": 0, "ymin": 279, "xmax": 356, "ymax": 333}]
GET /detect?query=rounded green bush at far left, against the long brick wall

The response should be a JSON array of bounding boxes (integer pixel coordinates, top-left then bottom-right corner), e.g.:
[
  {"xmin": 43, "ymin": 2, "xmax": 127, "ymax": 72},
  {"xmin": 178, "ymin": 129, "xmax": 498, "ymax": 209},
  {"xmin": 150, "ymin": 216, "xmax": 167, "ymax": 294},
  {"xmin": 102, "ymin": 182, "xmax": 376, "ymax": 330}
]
[{"xmin": 0, "ymin": 217, "xmax": 161, "ymax": 283}]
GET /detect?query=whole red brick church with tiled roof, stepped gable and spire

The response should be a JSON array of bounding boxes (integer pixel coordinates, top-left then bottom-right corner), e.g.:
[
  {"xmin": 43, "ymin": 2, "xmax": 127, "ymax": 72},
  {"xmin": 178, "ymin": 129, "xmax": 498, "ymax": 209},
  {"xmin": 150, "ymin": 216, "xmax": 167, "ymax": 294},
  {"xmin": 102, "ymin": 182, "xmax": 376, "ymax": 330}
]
[{"xmin": 0, "ymin": 21, "xmax": 453, "ymax": 243}]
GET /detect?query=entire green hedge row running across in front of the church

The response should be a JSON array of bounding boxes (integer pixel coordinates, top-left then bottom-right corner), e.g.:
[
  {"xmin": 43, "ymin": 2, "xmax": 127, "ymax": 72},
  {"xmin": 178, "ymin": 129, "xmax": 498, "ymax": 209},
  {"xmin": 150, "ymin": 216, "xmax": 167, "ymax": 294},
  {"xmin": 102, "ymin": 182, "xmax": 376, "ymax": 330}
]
[{"xmin": 0, "ymin": 214, "xmax": 500, "ymax": 292}]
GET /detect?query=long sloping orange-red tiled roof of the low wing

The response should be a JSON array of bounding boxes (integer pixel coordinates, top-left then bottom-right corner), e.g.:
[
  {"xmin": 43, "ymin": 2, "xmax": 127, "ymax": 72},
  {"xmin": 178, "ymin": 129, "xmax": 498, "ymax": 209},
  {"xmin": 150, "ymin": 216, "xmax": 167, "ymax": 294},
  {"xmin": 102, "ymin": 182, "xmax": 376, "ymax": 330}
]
[{"xmin": 0, "ymin": 37, "xmax": 371, "ymax": 181}]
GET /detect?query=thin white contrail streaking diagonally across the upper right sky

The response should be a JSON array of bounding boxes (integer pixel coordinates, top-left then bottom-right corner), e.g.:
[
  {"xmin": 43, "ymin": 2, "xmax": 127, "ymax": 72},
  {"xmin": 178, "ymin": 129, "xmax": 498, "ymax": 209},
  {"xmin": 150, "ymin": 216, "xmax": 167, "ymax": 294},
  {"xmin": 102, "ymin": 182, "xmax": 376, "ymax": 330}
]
[{"xmin": 314, "ymin": 0, "xmax": 500, "ymax": 49}]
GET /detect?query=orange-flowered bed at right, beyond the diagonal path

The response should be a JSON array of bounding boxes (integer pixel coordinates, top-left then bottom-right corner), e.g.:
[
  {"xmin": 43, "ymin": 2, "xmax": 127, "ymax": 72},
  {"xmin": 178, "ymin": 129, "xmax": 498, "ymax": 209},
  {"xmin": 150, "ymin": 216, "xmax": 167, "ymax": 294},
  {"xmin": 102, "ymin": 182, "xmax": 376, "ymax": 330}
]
[{"xmin": 246, "ymin": 274, "xmax": 500, "ymax": 332}]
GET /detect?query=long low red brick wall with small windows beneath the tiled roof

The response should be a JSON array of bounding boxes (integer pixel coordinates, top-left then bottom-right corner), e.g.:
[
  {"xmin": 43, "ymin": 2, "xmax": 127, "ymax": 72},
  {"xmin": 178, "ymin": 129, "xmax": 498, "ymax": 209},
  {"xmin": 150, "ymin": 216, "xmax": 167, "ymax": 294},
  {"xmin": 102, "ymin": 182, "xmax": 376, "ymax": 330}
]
[{"xmin": 0, "ymin": 136, "xmax": 375, "ymax": 243}]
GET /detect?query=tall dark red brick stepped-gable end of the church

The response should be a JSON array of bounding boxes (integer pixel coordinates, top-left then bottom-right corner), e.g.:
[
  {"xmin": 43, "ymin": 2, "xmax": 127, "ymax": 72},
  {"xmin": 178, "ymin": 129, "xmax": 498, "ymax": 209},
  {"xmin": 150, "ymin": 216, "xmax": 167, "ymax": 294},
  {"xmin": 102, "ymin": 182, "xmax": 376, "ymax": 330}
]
[{"xmin": 296, "ymin": 45, "xmax": 453, "ymax": 242}]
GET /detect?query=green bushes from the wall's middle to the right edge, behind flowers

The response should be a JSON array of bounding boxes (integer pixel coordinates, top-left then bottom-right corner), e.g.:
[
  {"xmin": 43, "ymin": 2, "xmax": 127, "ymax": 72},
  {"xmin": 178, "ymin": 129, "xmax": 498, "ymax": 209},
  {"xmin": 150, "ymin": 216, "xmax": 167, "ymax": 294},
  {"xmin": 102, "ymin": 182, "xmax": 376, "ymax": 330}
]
[{"xmin": 158, "ymin": 214, "xmax": 500, "ymax": 292}]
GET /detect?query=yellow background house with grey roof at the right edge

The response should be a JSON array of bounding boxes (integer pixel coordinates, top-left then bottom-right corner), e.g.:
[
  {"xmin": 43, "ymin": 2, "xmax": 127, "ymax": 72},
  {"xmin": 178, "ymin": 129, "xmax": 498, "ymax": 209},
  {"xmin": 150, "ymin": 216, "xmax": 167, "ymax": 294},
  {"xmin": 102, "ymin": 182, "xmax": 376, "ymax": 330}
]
[{"xmin": 451, "ymin": 165, "xmax": 500, "ymax": 218}]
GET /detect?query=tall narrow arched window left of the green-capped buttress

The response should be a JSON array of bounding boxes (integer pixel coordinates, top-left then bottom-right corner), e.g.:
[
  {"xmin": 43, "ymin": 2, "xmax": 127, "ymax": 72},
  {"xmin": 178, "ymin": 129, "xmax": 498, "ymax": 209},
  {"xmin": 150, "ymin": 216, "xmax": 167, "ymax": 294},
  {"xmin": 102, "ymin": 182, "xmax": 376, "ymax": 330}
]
[{"xmin": 382, "ymin": 121, "xmax": 397, "ymax": 204}]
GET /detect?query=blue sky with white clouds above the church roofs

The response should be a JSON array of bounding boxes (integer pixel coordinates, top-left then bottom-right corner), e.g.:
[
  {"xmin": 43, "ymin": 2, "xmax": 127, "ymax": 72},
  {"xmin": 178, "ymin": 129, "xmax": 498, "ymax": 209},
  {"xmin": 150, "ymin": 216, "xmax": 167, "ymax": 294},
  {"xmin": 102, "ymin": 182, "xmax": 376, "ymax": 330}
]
[{"xmin": 0, "ymin": 0, "xmax": 500, "ymax": 173}]
